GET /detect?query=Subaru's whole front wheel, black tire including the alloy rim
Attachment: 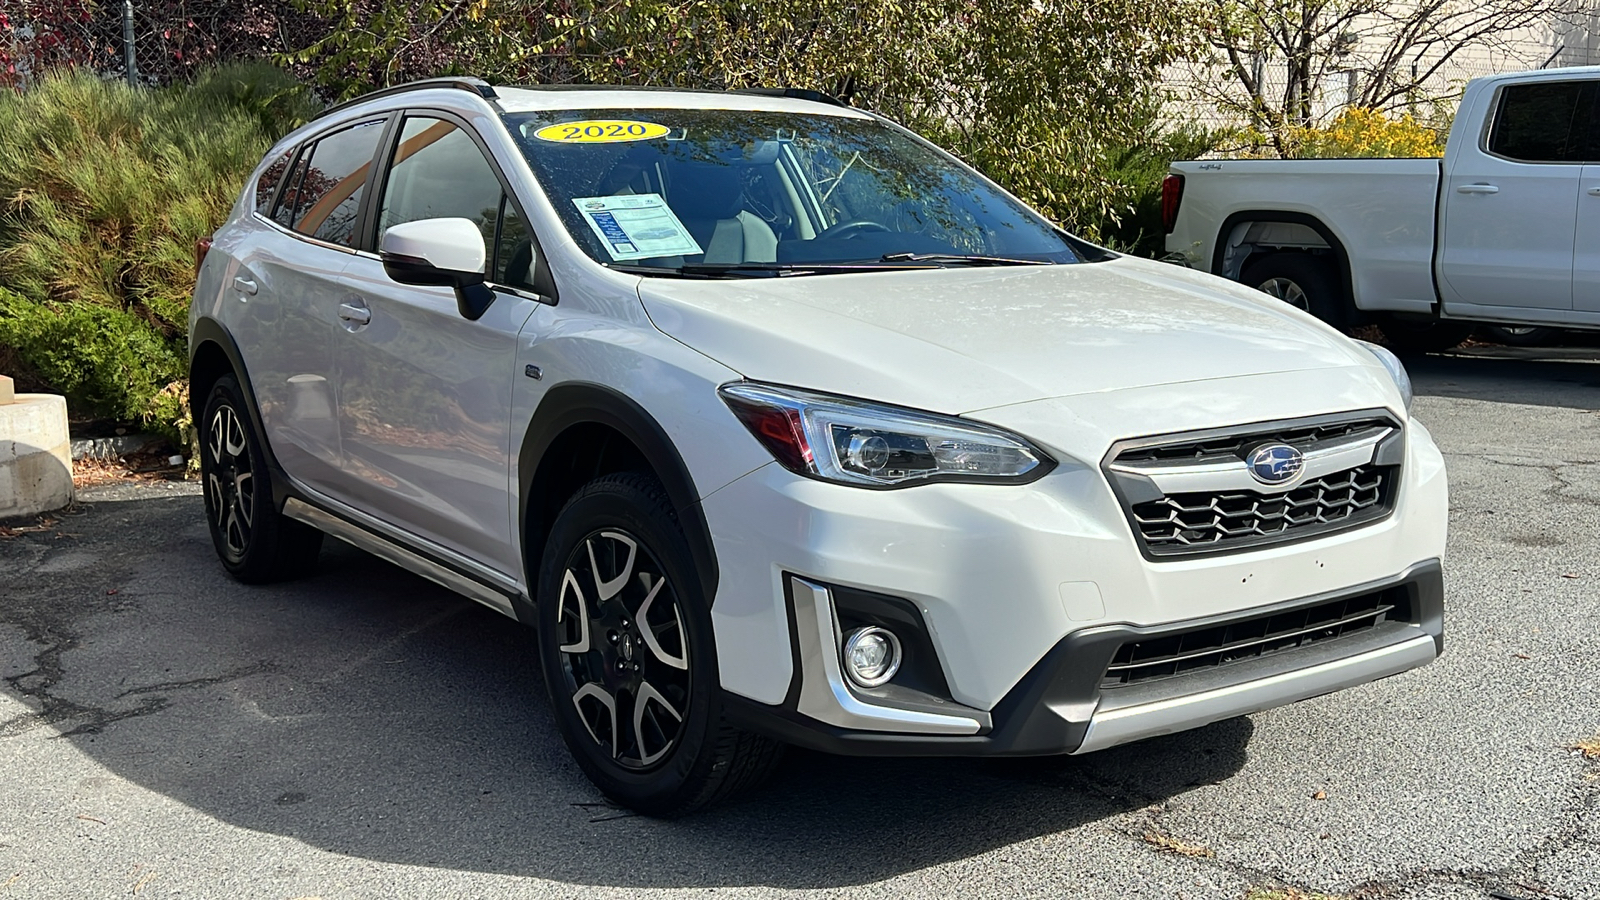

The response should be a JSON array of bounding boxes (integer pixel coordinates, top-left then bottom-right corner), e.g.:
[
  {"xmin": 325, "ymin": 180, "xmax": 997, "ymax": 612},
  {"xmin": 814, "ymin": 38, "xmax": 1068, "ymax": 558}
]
[{"xmin": 538, "ymin": 472, "xmax": 782, "ymax": 817}]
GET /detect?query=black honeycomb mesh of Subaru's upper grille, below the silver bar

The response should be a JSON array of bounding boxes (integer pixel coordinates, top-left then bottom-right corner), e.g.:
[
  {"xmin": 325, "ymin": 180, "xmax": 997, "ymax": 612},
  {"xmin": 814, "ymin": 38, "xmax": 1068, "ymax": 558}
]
[{"xmin": 1133, "ymin": 466, "xmax": 1392, "ymax": 554}]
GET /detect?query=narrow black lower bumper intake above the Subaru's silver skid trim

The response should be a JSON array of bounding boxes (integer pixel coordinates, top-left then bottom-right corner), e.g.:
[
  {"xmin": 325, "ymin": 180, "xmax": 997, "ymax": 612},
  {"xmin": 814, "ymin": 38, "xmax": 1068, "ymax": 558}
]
[{"xmin": 1101, "ymin": 586, "xmax": 1413, "ymax": 687}]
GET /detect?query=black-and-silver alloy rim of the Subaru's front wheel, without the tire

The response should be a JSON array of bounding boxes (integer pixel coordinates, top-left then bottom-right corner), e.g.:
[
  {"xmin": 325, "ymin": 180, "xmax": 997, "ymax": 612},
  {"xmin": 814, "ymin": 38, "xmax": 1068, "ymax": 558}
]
[{"xmin": 555, "ymin": 528, "xmax": 690, "ymax": 772}]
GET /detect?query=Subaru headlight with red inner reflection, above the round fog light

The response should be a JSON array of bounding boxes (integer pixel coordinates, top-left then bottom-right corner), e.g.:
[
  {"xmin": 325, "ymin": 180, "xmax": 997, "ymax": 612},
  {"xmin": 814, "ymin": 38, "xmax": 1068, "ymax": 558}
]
[{"xmin": 717, "ymin": 381, "xmax": 1056, "ymax": 487}]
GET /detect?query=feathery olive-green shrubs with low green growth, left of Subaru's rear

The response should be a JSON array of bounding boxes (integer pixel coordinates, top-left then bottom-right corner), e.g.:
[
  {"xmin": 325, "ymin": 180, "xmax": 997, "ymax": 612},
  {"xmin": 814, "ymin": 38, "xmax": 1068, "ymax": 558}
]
[{"xmin": 0, "ymin": 64, "xmax": 317, "ymax": 434}]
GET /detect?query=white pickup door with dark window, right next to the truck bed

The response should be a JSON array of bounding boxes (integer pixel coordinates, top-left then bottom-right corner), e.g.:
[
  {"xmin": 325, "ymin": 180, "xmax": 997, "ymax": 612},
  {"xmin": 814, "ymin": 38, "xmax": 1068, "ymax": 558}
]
[{"xmin": 1438, "ymin": 80, "xmax": 1600, "ymax": 314}]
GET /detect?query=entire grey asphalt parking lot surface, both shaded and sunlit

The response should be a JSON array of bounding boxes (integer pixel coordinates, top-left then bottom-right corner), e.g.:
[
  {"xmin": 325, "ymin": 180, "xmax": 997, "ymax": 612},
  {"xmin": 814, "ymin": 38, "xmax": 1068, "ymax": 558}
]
[{"xmin": 0, "ymin": 349, "xmax": 1600, "ymax": 900}]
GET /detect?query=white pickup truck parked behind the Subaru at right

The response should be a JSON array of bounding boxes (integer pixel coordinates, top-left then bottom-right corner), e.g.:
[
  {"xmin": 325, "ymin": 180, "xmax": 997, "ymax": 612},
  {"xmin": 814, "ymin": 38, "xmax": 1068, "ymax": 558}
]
[{"xmin": 1162, "ymin": 67, "xmax": 1600, "ymax": 349}]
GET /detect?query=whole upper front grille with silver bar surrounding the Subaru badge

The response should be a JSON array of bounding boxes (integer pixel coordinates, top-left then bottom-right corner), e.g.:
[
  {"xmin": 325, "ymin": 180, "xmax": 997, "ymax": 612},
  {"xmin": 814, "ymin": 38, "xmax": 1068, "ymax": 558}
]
[{"xmin": 1106, "ymin": 413, "xmax": 1403, "ymax": 559}]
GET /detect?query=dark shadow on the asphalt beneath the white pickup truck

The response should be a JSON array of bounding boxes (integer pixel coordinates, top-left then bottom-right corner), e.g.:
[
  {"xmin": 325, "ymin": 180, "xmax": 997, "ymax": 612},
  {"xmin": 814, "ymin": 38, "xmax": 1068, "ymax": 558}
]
[{"xmin": 1405, "ymin": 346, "xmax": 1600, "ymax": 410}]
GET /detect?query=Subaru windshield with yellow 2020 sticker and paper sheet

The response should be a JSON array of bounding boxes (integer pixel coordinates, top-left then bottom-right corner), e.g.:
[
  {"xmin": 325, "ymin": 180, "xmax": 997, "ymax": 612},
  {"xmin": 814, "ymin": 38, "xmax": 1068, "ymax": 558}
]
[{"xmin": 506, "ymin": 109, "xmax": 1078, "ymax": 275}]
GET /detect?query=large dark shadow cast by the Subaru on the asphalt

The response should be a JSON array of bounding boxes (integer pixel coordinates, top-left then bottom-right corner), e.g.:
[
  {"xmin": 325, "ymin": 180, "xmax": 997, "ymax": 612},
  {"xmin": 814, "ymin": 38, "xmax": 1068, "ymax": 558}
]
[{"xmin": 0, "ymin": 496, "xmax": 1253, "ymax": 889}]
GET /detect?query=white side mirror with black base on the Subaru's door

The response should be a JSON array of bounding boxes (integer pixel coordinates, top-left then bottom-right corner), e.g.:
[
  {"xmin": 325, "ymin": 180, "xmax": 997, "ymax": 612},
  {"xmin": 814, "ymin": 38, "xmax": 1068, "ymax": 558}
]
[{"xmin": 378, "ymin": 219, "xmax": 494, "ymax": 322}]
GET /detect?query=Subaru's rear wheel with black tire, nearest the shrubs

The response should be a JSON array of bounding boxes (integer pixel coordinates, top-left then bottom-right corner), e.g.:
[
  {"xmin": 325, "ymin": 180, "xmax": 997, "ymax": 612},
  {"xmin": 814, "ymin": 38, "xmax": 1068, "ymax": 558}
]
[{"xmin": 198, "ymin": 375, "xmax": 322, "ymax": 585}]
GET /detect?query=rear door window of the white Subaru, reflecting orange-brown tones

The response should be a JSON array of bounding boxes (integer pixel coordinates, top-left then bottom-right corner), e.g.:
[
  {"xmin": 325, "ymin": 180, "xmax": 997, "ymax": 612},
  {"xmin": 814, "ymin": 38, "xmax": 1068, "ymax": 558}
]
[{"xmin": 275, "ymin": 119, "xmax": 384, "ymax": 247}]
